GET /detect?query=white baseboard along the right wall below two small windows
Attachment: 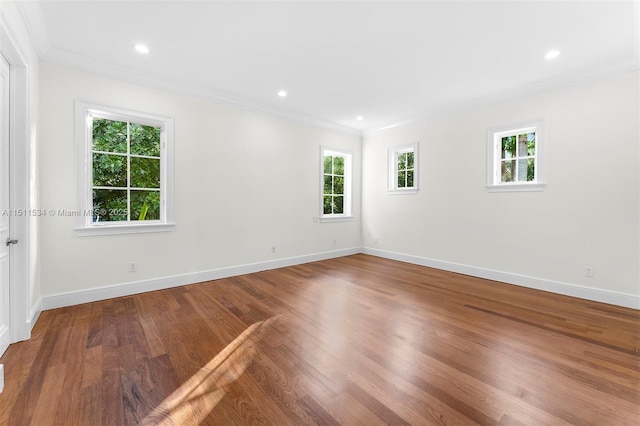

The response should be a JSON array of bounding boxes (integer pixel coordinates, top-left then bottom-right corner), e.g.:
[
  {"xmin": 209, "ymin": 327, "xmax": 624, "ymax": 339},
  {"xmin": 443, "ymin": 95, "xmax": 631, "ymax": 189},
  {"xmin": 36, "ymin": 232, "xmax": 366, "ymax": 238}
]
[{"xmin": 362, "ymin": 247, "xmax": 640, "ymax": 309}]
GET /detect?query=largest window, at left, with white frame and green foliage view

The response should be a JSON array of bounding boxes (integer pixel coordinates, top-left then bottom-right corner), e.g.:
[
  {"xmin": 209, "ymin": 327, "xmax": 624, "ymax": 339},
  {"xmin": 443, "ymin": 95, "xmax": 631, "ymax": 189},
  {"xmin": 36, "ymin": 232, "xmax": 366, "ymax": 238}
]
[{"xmin": 73, "ymin": 102, "xmax": 173, "ymax": 234}]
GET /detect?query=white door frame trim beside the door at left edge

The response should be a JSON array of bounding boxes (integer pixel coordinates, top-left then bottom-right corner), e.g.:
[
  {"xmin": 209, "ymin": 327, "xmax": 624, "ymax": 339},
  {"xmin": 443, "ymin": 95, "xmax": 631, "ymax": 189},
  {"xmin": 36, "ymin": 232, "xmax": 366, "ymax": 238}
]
[{"xmin": 0, "ymin": 15, "xmax": 32, "ymax": 343}]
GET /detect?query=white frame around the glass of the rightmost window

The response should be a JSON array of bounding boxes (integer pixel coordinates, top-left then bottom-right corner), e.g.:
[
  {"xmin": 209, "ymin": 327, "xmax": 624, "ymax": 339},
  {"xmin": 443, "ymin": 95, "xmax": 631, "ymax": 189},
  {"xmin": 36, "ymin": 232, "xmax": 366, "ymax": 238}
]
[{"xmin": 487, "ymin": 120, "xmax": 547, "ymax": 192}]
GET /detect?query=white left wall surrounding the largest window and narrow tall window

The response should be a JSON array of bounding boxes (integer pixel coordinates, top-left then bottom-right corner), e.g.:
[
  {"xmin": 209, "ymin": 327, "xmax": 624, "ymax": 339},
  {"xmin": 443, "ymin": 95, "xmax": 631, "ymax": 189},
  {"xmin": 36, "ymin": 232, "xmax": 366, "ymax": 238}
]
[{"xmin": 40, "ymin": 63, "xmax": 362, "ymax": 302}]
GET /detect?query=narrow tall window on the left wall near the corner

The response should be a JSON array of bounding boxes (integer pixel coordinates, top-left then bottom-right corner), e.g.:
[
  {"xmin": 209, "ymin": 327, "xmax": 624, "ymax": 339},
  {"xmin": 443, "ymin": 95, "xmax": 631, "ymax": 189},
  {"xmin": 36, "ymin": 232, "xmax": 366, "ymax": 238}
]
[{"xmin": 320, "ymin": 148, "xmax": 351, "ymax": 219}]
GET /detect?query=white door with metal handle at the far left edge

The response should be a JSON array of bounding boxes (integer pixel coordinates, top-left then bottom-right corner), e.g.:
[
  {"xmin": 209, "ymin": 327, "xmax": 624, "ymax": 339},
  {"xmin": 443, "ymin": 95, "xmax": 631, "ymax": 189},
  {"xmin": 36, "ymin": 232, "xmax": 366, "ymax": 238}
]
[{"xmin": 0, "ymin": 55, "xmax": 11, "ymax": 355}]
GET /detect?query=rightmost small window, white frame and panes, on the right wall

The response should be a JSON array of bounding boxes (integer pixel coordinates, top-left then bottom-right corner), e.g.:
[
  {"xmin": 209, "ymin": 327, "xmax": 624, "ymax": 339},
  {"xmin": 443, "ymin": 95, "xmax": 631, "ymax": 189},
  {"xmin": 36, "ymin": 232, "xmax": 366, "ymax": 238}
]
[{"xmin": 487, "ymin": 121, "xmax": 545, "ymax": 191}]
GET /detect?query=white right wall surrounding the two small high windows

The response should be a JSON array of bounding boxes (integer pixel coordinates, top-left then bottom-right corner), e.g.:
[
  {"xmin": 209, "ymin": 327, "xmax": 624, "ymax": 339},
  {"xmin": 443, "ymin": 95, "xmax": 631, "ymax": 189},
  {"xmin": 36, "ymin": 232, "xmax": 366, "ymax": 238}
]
[{"xmin": 363, "ymin": 72, "xmax": 640, "ymax": 308}]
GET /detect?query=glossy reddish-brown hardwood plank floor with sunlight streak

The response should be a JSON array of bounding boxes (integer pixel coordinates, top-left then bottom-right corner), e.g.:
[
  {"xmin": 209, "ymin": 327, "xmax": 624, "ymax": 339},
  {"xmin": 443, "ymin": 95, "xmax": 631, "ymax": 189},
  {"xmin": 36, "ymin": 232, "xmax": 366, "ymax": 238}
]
[{"xmin": 0, "ymin": 255, "xmax": 640, "ymax": 426}]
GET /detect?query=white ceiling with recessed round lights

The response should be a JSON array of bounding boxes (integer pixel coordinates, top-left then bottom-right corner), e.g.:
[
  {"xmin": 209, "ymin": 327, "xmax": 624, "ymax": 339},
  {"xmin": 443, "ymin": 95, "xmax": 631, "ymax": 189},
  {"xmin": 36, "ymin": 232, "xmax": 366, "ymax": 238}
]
[{"xmin": 15, "ymin": 0, "xmax": 640, "ymax": 131}]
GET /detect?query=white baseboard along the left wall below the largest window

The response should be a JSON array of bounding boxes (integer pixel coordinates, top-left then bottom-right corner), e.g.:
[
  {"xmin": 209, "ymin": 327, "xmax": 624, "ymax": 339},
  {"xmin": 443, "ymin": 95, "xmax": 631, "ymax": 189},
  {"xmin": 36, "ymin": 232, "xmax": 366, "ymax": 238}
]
[{"xmin": 42, "ymin": 247, "xmax": 362, "ymax": 310}]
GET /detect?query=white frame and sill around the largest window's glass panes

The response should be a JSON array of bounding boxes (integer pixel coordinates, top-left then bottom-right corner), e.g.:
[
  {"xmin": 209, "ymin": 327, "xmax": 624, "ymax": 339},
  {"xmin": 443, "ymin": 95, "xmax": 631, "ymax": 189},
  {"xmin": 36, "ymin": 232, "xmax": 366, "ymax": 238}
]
[{"xmin": 74, "ymin": 101, "xmax": 175, "ymax": 236}]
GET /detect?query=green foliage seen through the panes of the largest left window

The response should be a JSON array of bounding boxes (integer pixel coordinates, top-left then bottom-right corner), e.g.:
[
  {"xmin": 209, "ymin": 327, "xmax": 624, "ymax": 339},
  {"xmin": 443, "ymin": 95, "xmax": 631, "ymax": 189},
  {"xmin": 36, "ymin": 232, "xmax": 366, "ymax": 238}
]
[{"xmin": 92, "ymin": 117, "xmax": 161, "ymax": 222}]
